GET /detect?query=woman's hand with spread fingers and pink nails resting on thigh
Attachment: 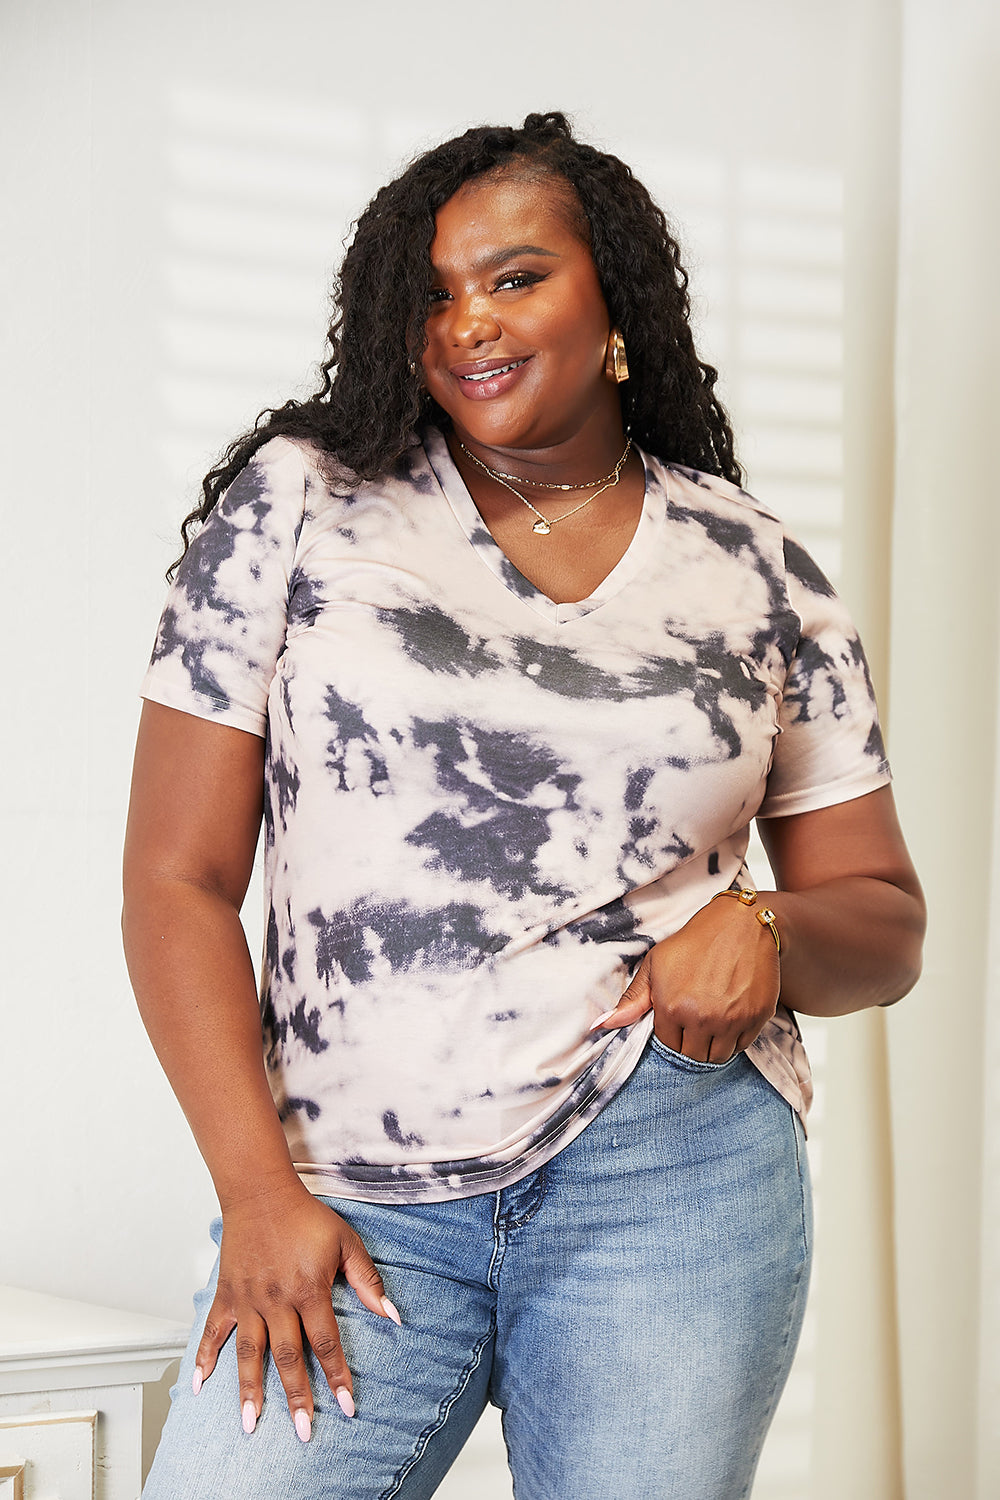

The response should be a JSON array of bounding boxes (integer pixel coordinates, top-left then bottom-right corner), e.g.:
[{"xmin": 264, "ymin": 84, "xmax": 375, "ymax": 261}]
[{"xmin": 193, "ymin": 1181, "xmax": 399, "ymax": 1443}]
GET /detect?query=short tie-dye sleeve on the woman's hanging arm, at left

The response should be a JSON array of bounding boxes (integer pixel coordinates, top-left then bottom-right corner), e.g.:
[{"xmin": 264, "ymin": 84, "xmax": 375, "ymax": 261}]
[{"xmin": 139, "ymin": 438, "xmax": 306, "ymax": 737}]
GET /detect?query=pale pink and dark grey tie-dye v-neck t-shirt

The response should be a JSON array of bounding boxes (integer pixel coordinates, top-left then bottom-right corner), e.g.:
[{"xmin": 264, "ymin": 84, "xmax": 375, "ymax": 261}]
[{"xmin": 142, "ymin": 431, "xmax": 889, "ymax": 1202}]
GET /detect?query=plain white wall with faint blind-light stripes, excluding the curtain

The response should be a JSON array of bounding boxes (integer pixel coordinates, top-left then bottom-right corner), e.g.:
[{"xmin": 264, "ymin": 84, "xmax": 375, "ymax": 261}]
[{"xmin": 0, "ymin": 0, "xmax": 895, "ymax": 1500}]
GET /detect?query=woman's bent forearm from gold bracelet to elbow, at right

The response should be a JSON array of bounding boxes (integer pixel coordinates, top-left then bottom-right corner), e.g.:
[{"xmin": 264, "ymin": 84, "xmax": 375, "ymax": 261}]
[{"xmin": 747, "ymin": 876, "xmax": 924, "ymax": 1016}]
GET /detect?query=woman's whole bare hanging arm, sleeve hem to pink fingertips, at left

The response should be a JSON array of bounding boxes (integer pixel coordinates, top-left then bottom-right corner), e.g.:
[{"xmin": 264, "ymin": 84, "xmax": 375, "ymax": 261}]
[{"xmin": 123, "ymin": 704, "xmax": 399, "ymax": 1442}]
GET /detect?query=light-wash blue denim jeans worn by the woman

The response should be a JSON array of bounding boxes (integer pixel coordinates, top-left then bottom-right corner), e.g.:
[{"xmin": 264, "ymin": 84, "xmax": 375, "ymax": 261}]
[{"xmin": 142, "ymin": 1038, "xmax": 811, "ymax": 1500}]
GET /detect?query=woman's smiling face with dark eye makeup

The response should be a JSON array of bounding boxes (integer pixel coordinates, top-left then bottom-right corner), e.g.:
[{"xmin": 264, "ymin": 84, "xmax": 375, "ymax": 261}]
[{"xmin": 423, "ymin": 176, "xmax": 622, "ymax": 471}]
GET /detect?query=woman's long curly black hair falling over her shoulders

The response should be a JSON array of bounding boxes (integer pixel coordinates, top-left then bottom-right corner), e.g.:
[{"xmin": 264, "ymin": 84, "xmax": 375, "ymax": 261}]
[{"xmin": 171, "ymin": 111, "xmax": 742, "ymax": 572}]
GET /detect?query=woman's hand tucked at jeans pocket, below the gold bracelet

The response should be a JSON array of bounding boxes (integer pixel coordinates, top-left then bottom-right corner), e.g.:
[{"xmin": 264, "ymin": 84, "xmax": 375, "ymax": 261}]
[{"xmin": 594, "ymin": 900, "xmax": 780, "ymax": 1062}]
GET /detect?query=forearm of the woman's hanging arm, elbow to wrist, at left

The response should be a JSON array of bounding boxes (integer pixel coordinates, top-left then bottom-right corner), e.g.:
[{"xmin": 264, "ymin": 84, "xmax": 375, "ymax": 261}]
[{"xmin": 123, "ymin": 876, "xmax": 298, "ymax": 1209}]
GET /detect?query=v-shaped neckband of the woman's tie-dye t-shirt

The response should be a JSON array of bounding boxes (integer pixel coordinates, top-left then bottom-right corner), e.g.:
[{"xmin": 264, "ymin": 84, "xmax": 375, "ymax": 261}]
[{"xmin": 424, "ymin": 428, "xmax": 667, "ymax": 626}]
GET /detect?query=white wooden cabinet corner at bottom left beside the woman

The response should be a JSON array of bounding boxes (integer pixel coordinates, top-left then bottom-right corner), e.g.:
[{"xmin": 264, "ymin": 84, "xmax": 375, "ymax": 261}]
[{"xmin": 0, "ymin": 1287, "xmax": 187, "ymax": 1500}]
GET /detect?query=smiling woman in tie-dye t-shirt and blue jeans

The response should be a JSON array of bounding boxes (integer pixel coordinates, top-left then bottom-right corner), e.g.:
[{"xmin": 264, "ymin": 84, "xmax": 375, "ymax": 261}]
[{"xmin": 124, "ymin": 114, "xmax": 924, "ymax": 1500}]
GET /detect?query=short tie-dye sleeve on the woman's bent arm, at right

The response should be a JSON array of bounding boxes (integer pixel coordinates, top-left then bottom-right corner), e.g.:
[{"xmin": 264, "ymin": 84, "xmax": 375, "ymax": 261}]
[{"xmin": 757, "ymin": 537, "xmax": 892, "ymax": 818}]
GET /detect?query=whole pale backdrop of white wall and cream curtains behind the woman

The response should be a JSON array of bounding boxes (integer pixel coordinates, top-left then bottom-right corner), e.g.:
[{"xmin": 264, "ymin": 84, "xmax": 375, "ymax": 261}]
[{"xmin": 0, "ymin": 0, "xmax": 1000, "ymax": 1500}]
